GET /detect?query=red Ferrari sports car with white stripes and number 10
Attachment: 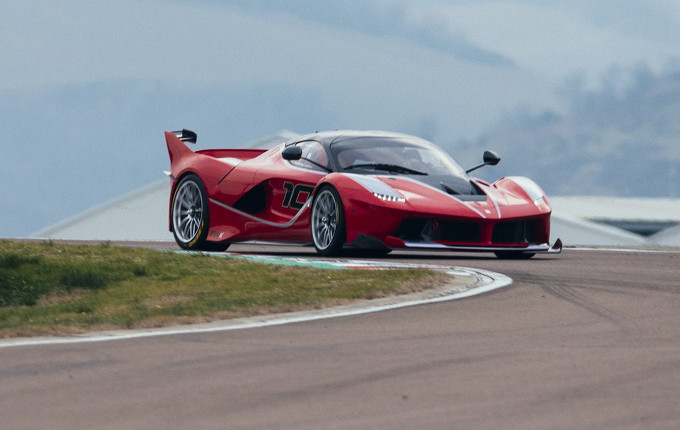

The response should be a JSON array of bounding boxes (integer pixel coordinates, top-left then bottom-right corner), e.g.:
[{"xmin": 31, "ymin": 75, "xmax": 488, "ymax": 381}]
[{"xmin": 165, "ymin": 130, "xmax": 562, "ymax": 258}]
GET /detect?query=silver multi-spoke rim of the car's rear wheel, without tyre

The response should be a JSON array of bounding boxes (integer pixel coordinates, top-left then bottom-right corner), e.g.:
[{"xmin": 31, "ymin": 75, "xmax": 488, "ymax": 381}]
[{"xmin": 172, "ymin": 180, "xmax": 203, "ymax": 243}]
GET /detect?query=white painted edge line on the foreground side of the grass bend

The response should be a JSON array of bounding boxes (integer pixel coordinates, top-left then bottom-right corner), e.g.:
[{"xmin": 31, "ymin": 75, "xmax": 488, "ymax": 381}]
[{"xmin": 0, "ymin": 265, "xmax": 512, "ymax": 348}]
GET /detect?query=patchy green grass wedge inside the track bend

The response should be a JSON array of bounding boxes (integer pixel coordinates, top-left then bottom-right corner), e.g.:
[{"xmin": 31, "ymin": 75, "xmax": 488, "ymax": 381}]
[{"xmin": 0, "ymin": 241, "xmax": 449, "ymax": 337}]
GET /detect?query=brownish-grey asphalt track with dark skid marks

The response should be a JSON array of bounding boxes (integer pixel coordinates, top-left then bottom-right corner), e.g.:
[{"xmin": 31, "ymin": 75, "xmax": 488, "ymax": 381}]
[{"xmin": 0, "ymin": 246, "xmax": 680, "ymax": 429}]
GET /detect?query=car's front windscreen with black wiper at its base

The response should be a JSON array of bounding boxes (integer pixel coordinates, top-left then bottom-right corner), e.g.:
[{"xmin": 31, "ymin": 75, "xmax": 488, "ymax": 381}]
[{"xmin": 330, "ymin": 137, "xmax": 467, "ymax": 177}]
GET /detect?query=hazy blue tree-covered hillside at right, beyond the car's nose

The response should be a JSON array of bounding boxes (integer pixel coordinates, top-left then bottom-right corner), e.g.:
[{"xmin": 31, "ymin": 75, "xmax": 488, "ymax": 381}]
[{"xmin": 447, "ymin": 67, "xmax": 680, "ymax": 198}]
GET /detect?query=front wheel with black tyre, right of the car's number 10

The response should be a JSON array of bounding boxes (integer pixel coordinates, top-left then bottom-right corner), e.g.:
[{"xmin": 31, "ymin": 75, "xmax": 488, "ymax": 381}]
[{"xmin": 310, "ymin": 186, "xmax": 345, "ymax": 256}]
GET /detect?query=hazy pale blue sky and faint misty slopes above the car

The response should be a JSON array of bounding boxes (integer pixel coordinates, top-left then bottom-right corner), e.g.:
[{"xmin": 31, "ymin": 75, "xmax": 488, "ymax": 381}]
[{"xmin": 0, "ymin": 0, "xmax": 680, "ymax": 237}]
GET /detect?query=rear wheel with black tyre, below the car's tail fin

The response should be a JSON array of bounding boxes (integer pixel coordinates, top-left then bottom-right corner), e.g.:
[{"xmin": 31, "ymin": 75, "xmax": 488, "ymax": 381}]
[{"xmin": 171, "ymin": 173, "xmax": 229, "ymax": 251}]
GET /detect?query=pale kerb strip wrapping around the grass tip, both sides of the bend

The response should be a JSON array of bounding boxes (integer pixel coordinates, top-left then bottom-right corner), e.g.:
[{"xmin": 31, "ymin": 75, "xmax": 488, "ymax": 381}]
[{"xmin": 0, "ymin": 251, "xmax": 512, "ymax": 348}]
